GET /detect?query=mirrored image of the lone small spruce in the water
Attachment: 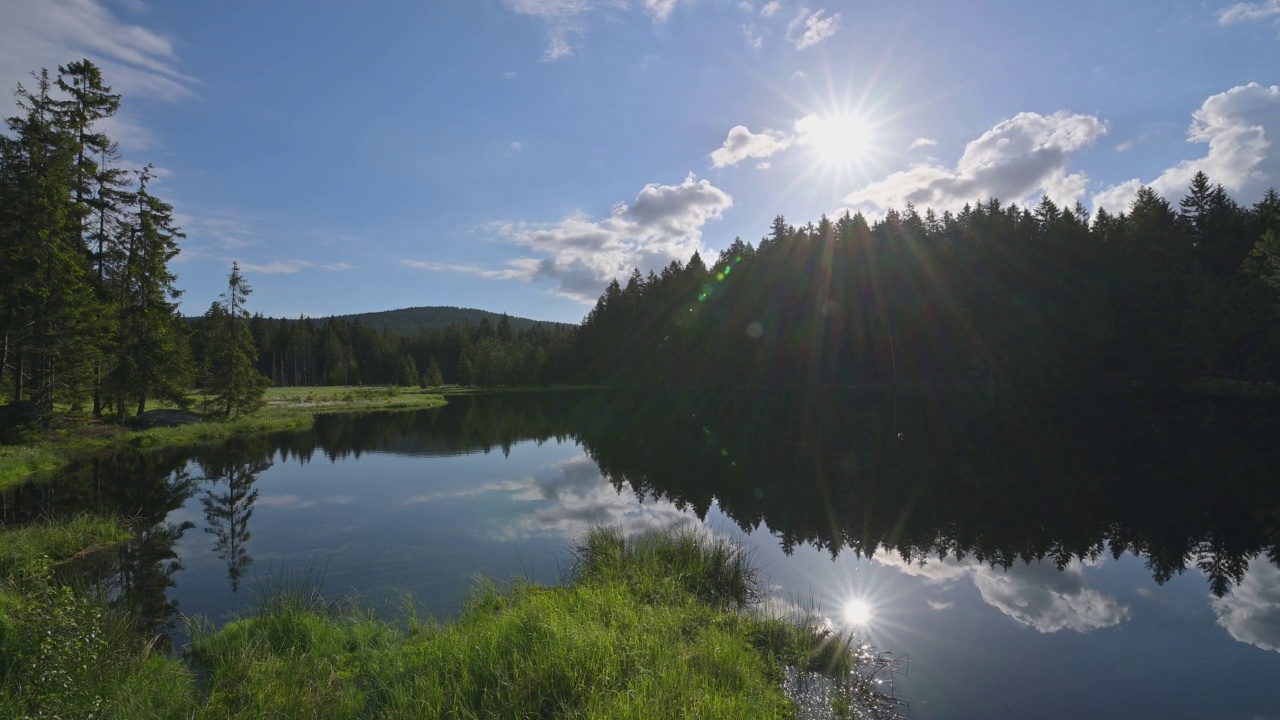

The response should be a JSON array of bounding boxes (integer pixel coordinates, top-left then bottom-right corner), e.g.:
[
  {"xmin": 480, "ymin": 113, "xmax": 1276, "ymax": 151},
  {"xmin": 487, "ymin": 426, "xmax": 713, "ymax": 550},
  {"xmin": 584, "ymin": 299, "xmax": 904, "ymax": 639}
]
[{"xmin": 198, "ymin": 439, "xmax": 271, "ymax": 592}]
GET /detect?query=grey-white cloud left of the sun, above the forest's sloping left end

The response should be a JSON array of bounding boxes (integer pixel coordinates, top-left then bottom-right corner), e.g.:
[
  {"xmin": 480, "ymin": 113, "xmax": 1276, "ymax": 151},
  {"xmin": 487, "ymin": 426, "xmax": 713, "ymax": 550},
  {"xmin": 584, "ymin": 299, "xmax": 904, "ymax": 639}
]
[{"xmin": 473, "ymin": 173, "xmax": 733, "ymax": 302}]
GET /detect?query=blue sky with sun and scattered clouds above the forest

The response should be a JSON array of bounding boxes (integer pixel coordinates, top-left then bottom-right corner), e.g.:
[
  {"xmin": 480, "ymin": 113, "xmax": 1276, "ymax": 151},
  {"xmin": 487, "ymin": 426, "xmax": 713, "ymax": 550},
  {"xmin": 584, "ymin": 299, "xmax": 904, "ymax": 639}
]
[{"xmin": 0, "ymin": 0, "xmax": 1280, "ymax": 323}]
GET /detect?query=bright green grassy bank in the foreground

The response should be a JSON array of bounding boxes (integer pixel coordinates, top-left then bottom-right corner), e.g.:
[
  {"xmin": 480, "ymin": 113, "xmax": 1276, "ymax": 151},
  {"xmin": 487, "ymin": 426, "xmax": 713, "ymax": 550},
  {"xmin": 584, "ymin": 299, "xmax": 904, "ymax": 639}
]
[{"xmin": 0, "ymin": 529, "xmax": 885, "ymax": 719}]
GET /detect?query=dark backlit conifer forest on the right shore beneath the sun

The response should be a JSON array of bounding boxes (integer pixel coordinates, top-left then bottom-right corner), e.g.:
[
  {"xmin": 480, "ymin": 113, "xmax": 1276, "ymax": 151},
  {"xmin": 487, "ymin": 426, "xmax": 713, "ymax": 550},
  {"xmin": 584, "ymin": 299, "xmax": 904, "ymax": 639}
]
[{"xmin": 567, "ymin": 173, "xmax": 1280, "ymax": 384}]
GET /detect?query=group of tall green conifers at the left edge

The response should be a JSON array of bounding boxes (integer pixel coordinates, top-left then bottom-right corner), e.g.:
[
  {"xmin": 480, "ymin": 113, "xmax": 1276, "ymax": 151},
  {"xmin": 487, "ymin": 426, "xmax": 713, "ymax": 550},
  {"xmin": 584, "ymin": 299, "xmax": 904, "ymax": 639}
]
[{"xmin": 0, "ymin": 60, "xmax": 195, "ymax": 416}]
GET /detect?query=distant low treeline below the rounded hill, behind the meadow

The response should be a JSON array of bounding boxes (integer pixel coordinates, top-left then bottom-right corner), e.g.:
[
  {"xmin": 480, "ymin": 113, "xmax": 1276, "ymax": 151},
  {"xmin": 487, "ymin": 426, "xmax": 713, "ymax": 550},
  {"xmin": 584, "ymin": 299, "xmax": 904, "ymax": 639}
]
[{"xmin": 192, "ymin": 310, "xmax": 573, "ymax": 387}]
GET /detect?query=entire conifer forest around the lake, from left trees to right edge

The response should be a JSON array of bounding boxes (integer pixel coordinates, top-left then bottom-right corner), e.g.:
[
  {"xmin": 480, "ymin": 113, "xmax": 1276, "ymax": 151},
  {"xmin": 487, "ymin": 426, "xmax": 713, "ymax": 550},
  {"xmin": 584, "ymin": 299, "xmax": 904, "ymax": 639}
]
[{"xmin": 0, "ymin": 60, "xmax": 1280, "ymax": 416}]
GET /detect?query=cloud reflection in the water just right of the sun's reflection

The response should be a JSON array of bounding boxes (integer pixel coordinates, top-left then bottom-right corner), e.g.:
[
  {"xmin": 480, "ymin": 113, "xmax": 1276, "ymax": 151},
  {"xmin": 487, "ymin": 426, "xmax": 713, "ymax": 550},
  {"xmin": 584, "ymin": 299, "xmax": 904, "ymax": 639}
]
[{"xmin": 874, "ymin": 551, "xmax": 1129, "ymax": 633}]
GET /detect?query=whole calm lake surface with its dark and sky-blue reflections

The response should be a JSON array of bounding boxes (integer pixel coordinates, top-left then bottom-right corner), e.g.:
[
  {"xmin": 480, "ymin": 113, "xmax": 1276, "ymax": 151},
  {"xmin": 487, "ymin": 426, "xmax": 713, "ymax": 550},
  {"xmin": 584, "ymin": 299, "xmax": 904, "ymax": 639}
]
[{"xmin": 3, "ymin": 391, "xmax": 1280, "ymax": 719}]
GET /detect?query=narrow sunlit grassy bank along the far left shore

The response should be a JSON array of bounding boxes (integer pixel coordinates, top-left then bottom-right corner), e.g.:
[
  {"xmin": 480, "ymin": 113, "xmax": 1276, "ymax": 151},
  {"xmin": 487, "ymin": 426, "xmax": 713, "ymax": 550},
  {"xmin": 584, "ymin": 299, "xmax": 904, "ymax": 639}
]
[{"xmin": 0, "ymin": 387, "xmax": 445, "ymax": 491}]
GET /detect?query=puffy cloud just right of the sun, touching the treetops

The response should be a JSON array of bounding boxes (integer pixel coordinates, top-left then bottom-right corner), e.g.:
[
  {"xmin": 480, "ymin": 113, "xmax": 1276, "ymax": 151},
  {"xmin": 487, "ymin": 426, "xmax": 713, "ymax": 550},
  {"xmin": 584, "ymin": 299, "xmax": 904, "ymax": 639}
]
[{"xmin": 844, "ymin": 111, "xmax": 1107, "ymax": 213}]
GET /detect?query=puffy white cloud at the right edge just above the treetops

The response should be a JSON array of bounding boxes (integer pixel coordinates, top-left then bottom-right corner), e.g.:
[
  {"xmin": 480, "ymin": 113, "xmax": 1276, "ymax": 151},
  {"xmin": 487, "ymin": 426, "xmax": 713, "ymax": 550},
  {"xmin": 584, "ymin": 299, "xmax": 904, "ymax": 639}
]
[{"xmin": 1093, "ymin": 82, "xmax": 1280, "ymax": 211}]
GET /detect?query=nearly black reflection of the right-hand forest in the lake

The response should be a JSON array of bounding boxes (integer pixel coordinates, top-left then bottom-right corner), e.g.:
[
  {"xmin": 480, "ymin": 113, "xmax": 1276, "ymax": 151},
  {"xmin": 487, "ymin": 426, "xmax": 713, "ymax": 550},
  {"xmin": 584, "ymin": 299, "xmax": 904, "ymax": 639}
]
[{"xmin": 582, "ymin": 391, "xmax": 1280, "ymax": 594}]
